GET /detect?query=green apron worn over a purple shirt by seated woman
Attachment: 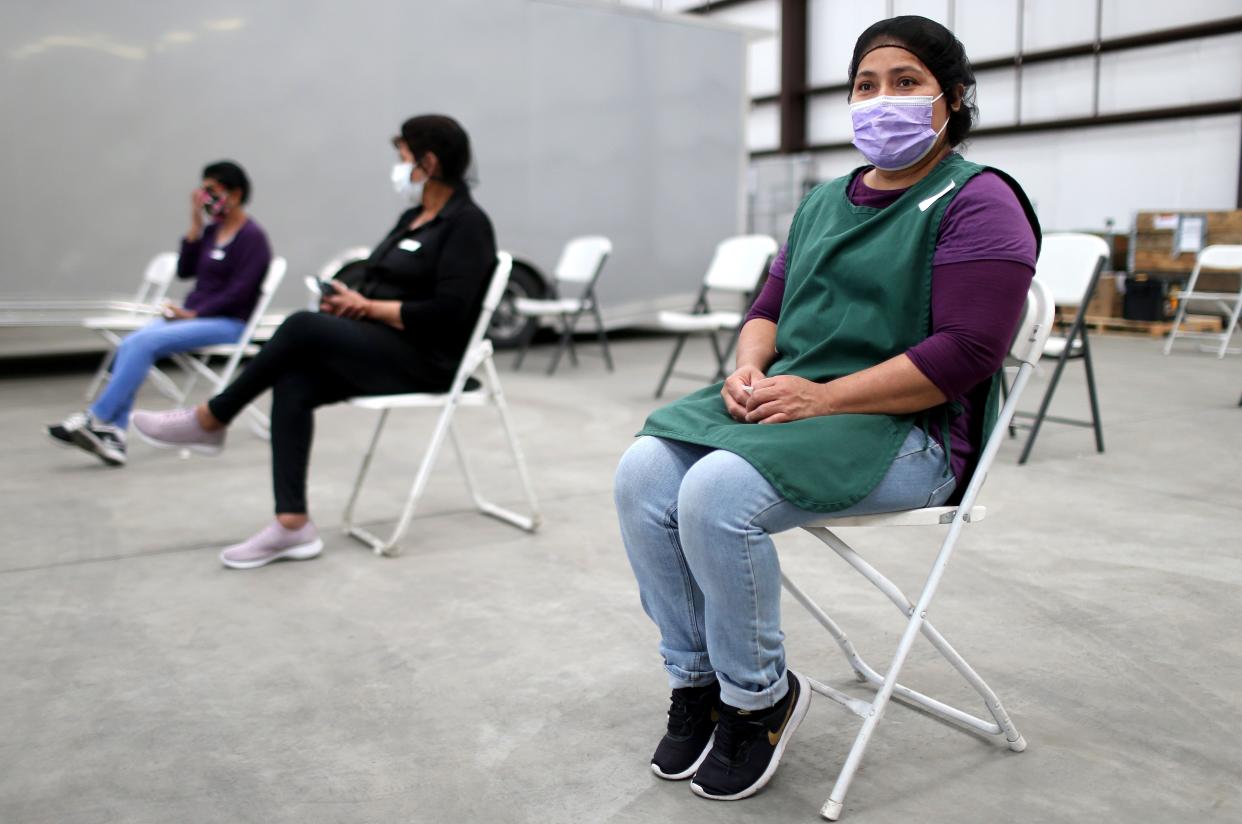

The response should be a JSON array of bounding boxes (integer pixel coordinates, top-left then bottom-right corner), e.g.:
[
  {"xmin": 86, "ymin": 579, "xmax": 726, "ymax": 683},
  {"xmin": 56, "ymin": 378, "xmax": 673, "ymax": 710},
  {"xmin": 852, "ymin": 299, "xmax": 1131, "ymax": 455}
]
[{"xmin": 638, "ymin": 153, "xmax": 1038, "ymax": 512}]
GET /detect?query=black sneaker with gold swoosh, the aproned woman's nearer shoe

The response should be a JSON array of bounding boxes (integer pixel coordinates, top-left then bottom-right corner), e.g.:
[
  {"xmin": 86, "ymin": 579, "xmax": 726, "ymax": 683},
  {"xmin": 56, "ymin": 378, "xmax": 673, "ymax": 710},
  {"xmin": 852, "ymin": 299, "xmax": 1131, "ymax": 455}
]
[{"xmin": 691, "ymin": 670, "xmax": 811, "ymax": 802}]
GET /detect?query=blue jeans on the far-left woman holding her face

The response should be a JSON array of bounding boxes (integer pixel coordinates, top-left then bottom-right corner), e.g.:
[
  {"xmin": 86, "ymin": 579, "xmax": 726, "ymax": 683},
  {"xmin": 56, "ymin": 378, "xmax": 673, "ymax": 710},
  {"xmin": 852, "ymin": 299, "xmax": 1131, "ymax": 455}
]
[{"xmin": 91, "ymin": 318, "xmax": 246, "ymax": 429}]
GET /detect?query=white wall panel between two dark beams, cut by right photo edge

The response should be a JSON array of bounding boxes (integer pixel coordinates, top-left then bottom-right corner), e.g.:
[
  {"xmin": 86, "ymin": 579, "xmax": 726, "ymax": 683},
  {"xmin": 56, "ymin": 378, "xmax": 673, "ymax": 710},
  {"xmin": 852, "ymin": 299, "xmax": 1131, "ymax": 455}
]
[{"xmin": 1099, "ymin": 32, "xmax": 1242, "ymax": 112}]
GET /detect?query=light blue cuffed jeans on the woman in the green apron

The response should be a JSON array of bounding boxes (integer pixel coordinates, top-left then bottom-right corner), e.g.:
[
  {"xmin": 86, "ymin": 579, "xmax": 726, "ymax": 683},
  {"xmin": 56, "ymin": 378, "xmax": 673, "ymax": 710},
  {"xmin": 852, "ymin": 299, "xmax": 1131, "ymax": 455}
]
[{"xmin": 614, "ymin": 424, "xmax": 956, "ymax": 710}]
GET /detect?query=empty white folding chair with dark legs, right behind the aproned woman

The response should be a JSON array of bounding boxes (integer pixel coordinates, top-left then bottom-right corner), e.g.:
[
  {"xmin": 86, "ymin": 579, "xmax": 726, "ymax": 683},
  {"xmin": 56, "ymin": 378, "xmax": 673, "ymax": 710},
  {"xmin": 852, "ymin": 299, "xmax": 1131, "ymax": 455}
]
[{"xmin": 1010, "ymin": 232, "xmax": 1109, "ymax": 464}]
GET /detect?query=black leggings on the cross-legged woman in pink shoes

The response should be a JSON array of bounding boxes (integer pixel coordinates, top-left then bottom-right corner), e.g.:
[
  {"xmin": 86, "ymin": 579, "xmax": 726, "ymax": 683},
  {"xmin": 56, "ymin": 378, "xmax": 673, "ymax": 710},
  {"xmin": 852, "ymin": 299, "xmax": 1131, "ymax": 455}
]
[{"xmin": 207, "ymin": 312, "xmax": 453, "ymax": 513}]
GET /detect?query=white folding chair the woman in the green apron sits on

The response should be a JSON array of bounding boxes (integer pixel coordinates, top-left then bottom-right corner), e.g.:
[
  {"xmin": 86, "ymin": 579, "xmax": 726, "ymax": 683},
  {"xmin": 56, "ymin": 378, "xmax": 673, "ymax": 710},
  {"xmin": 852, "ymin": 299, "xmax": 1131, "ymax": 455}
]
[{"xmin": 781, "ymin": 281, "xmax": 1053, "ymax": 822}]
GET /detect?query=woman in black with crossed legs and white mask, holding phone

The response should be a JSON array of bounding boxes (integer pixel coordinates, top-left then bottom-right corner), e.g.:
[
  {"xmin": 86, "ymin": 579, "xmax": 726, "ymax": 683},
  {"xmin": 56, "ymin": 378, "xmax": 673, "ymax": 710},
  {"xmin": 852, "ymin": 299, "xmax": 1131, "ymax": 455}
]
[{"xmin": 133, "ymin": 114, "xmax": 496, "ymax": 569}]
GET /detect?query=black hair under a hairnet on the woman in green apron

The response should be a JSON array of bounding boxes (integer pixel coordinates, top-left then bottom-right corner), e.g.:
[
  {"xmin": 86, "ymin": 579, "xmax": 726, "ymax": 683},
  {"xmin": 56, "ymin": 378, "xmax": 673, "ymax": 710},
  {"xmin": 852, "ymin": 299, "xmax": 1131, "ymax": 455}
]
[{"xmin": 850, "ymin": 15, "xmax": 979, "ymax": 145}]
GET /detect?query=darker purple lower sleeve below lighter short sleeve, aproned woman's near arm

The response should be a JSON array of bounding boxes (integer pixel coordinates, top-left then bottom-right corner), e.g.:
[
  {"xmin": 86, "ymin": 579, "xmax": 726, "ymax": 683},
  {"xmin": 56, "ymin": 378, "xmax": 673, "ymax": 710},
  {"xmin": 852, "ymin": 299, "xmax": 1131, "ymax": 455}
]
[{"xmin": 905, "ymin": 260, "xmax": 1035, "ymax": 400}]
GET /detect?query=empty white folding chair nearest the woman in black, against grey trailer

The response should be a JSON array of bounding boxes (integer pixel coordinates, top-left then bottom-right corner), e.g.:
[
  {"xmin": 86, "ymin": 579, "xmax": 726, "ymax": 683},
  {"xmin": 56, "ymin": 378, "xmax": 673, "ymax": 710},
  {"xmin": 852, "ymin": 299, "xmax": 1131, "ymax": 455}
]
[{"xmin": 513, "ymin": 236, "xmax": 612, "ymax": 374}]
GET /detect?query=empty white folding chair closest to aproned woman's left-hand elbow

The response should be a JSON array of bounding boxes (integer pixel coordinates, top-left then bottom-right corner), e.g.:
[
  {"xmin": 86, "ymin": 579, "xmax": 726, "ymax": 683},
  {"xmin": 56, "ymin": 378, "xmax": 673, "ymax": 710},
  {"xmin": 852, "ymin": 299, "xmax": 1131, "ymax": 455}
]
[{"xmin": 656, "ymin": 235, "xmax": 779, "ymax": 398}]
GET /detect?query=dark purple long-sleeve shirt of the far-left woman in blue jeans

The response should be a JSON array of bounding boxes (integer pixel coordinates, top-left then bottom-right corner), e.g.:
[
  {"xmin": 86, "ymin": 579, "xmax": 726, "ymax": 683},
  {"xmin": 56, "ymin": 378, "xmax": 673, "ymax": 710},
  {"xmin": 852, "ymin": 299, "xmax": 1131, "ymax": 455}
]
[{"xmin": 176, "ymin": 217, "xmax": 272, "ymax": 321}]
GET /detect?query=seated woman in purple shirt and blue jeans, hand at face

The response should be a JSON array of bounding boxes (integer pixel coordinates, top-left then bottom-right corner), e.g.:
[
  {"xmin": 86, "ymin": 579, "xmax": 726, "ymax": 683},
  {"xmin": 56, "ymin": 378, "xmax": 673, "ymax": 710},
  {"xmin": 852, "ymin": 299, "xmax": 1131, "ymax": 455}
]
[{"xmin": 47, "ymin": 160, "xmax": 272, "ymax": 466}]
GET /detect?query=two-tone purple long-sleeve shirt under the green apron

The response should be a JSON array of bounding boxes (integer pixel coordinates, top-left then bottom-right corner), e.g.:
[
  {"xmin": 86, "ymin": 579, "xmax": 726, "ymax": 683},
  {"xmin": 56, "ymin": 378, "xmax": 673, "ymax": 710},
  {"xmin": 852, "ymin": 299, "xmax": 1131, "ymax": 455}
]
[{"xmin": 746, "ymin": 172, "xmax": 1036, "ymax": 485}]
